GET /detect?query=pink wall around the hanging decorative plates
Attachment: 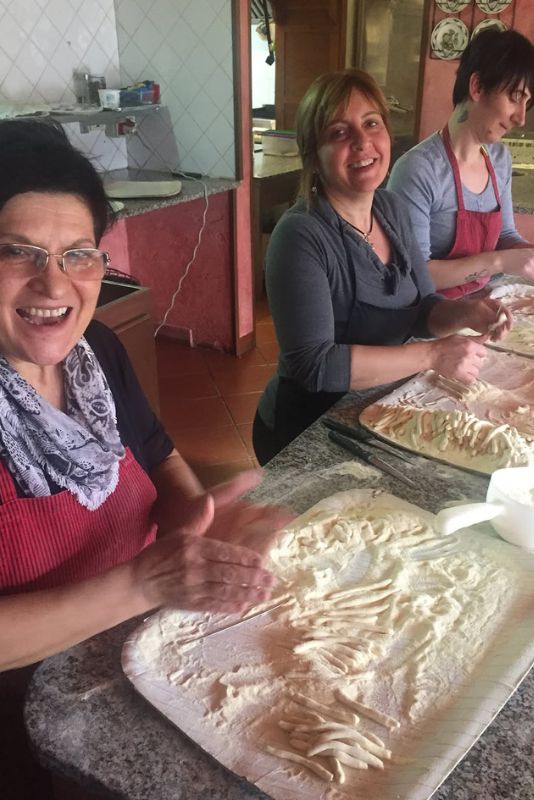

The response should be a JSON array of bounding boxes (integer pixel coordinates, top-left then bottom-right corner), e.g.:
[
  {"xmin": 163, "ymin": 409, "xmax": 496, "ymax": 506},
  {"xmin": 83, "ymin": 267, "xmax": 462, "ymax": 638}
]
[{"xmin": 418, "ymin": 0, "xmax": 534, "ymax": 140}]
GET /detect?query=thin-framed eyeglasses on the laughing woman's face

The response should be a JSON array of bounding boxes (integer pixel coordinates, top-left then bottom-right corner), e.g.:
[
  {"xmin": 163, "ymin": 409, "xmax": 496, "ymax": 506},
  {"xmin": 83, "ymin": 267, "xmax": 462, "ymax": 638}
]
[{"xmin": 0, "ymin": 244, "xmax": 111, "ymax": 281}]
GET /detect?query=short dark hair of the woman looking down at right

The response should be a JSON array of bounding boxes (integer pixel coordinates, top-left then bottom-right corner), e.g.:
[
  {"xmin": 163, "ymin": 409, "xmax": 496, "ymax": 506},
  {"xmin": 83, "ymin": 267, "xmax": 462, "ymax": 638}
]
[{"xmin": 452, "ymin": 26, "xmax": 534, "ymax": 106}]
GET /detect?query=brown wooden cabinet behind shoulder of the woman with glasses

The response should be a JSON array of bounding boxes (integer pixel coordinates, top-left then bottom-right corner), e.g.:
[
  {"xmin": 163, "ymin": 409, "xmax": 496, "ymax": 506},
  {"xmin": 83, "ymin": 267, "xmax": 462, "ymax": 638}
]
[{"xmin": 94, "ymin": 281, "xmax": 159, "ymax": 414}]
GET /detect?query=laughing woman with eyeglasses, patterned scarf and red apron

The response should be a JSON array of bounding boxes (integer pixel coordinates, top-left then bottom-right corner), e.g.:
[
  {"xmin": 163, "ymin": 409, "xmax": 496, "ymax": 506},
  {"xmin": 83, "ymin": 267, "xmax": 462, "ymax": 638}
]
[{"xmin": 0, "ymin": 121, "xmax": 287, "ymax": 797}]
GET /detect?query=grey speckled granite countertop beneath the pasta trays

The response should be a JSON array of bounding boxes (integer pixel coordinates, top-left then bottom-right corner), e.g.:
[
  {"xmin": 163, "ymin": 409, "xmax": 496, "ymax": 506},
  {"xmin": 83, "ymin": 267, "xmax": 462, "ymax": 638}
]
[{"xmin": 26, "ymin": 389, "xmax": 534, "ymax": 800}]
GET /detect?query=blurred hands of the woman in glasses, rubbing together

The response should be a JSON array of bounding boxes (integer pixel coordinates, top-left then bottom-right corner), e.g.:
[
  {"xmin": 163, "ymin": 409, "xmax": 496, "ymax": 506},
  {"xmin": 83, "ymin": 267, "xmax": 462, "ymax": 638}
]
[{"xmin": 133, "ymin": 495, "xmax": 290, "ymax": 613}]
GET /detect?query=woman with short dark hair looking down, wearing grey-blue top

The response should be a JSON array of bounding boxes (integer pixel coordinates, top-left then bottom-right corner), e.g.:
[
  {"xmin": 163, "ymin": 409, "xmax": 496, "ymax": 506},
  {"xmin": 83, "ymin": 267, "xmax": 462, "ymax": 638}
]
[{"xmin": 388, "ymin": 27, "xmax": 534, "ymax": 298}]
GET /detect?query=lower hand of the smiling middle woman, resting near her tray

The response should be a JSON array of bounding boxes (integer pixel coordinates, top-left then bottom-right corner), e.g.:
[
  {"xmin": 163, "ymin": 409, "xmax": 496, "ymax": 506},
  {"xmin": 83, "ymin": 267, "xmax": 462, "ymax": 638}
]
[{"xmin": 429, "ymin": 335, "xmax": 488, "ymax": 383}]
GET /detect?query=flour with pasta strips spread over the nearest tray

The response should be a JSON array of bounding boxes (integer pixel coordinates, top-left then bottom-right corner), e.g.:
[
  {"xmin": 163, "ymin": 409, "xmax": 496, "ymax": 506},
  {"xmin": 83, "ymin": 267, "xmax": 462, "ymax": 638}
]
[{"xmin": 133, "ymin": 490, "xmax": 522, "ymax": 798}]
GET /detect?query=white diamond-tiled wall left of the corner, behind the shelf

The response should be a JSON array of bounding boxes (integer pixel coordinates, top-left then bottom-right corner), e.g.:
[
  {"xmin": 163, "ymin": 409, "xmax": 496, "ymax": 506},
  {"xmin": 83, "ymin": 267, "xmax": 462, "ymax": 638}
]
[{"xmin": 0, "ymin": 0, "xmax": 126, "ymax": 169}]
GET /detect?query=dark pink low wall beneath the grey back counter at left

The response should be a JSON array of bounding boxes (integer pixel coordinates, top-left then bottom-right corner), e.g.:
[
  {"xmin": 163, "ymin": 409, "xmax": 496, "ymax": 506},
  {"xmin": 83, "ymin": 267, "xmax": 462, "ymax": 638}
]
[{"xmin": 102, "ymin": 192, "xmax": 234, "ymax": 351}]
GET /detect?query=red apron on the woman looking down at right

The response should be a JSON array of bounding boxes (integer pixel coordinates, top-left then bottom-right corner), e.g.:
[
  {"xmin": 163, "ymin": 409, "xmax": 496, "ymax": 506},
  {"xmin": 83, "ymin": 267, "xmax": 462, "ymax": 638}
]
[{"xmin": 438, "ymin": 125, "xmax": 502, "ymax": 300}]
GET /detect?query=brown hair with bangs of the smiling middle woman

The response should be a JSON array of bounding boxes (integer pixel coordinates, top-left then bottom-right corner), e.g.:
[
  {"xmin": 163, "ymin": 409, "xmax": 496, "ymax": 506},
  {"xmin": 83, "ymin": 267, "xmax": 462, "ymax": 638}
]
[{"xmin": 296, "ymin": 69, "xmax": 391, "ymax": 208}]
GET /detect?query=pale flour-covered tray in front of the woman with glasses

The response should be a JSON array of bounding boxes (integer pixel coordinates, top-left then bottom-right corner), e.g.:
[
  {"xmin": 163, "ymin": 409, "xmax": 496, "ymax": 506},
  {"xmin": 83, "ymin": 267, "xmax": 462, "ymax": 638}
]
[{"xmin": 122, "ymin": 490, "xmax": 534, "ymax": 800}]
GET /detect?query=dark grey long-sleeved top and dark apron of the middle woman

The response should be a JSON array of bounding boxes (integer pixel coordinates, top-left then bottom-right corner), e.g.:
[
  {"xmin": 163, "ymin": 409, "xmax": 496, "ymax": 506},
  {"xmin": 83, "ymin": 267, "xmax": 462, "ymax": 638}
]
[{"xmin": 259, "ymin": 190, "xmax": 441, "ymax": 429}]
